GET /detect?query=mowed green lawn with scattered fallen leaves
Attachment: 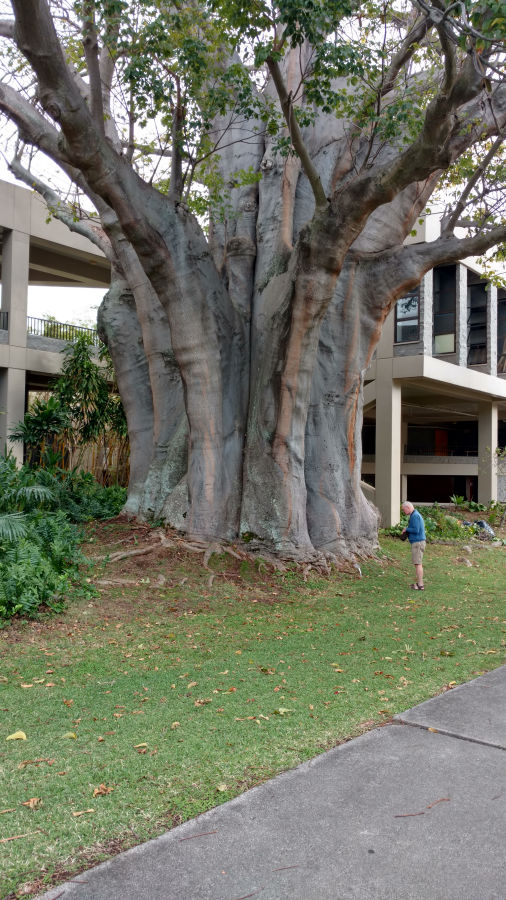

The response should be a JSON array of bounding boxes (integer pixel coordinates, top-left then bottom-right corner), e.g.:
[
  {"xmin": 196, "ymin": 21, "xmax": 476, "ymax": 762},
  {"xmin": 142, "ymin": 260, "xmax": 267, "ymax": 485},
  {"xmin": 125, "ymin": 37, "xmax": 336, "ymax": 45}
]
[{"xmin": 0, "ymin": 525, "xmax": 506, "ymax": 898}]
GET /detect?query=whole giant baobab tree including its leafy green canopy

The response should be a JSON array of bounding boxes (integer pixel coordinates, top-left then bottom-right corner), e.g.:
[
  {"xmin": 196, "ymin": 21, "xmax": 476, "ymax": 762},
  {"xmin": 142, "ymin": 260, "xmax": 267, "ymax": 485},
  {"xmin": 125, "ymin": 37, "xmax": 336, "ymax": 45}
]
[{"xmin": 0, "ymin": 0, "xmax": 506, "ymax": 561}]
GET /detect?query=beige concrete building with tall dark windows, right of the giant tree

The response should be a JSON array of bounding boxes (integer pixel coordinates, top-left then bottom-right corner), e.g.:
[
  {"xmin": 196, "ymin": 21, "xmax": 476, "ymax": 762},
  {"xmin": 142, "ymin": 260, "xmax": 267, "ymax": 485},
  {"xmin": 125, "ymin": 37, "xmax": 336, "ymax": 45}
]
[{"xmin": 362, "ymin": 219, "xmax": 506, "ymax": 526}]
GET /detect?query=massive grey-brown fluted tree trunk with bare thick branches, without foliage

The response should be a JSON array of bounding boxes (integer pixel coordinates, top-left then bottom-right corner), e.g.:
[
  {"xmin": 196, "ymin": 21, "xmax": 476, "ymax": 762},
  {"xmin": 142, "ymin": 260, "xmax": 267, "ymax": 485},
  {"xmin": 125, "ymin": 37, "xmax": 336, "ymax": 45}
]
[{"xmin": 0, "ymin": 0, "xmax": 506, "ymax": 561}]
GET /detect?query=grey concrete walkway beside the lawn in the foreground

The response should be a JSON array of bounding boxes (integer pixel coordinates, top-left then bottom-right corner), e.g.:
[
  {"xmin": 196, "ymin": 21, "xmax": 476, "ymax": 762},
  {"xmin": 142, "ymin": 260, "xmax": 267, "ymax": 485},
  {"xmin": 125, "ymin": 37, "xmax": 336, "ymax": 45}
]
[{"xmin": 39, "ymin": 666, "xmax": 506, "ymax": 900}]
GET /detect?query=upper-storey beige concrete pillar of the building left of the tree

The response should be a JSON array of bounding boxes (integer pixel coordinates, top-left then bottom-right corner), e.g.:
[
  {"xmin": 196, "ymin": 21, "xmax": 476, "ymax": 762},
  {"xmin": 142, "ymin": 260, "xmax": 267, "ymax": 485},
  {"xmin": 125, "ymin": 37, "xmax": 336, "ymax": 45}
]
[{"xmin": 2, "ymin": 231, "xmax": 30, "ymax": 347}]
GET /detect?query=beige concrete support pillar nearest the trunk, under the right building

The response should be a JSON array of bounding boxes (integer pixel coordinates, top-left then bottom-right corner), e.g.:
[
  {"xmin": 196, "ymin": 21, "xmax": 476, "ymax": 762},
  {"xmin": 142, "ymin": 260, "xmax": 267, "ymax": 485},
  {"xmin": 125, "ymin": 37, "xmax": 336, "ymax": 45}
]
[{"xmin": 375, "ymin": 359, "xmax": 402, "ymax": 528}]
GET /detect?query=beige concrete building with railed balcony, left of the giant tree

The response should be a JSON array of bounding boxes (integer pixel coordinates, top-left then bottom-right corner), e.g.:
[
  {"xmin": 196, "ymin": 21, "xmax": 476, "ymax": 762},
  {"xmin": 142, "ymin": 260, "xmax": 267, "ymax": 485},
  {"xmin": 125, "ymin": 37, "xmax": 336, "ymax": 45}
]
[{"xmin": 0, "ymin": 181, "xmax": 110, "ymax": 461}]
